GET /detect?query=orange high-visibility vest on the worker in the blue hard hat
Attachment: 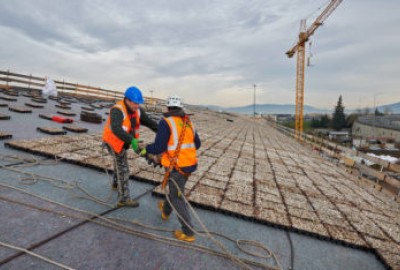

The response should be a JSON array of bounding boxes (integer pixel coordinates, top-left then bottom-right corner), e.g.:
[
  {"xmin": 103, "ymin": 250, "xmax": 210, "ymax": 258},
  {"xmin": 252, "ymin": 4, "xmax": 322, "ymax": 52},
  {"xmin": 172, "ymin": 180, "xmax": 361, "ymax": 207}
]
[{"xmin": 103, "ymin": 100, "xmax": 140, "ymax": 153}]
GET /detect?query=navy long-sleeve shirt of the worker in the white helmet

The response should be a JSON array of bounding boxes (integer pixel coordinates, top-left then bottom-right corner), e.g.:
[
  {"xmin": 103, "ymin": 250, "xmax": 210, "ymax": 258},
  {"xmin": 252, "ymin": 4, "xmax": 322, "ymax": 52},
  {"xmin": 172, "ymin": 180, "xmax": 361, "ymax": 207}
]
[{"xmin": 146, "ymin": 111, "xmax": 201, "ymax": 173}]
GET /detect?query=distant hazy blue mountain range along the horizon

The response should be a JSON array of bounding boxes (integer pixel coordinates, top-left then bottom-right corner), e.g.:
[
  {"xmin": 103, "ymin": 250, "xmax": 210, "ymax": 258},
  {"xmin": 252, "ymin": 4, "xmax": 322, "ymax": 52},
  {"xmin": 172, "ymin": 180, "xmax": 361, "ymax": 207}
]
[{"xmin": 203, "ymin": 102, "xmax": 400, "ymax": 115}]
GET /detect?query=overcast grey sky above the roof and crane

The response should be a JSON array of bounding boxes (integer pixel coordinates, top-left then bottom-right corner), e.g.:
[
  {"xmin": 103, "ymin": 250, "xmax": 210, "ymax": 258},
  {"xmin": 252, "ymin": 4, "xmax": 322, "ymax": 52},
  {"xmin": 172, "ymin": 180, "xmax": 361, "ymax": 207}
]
[{"xmin": 0, "ymin": 0, "xmax": 400, "ymax": 108}]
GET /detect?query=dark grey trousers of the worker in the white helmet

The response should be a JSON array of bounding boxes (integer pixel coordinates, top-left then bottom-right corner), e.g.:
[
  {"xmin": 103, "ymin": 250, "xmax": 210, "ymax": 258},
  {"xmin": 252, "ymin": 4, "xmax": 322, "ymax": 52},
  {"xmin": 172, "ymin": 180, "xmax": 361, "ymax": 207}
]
[{"xmin": 163, "ymin": 170, "xmax": 193, "ymax": 236}]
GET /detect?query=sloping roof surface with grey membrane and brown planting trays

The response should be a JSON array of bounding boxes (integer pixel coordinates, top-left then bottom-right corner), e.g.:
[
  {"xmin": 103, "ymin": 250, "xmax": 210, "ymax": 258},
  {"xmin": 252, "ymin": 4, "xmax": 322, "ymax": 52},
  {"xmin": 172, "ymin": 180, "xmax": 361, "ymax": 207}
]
[{"xmin": 0, "ymin": 87, "xmax": 400, "ymax": 269}]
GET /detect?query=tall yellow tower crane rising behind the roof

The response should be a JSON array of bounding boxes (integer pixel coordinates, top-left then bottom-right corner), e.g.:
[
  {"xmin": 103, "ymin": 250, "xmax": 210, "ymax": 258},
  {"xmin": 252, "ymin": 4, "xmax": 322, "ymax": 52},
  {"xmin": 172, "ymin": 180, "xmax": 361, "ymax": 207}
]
[{"xmin": 286, "ymin": 0, "xmax": 343, "ymax": 140}]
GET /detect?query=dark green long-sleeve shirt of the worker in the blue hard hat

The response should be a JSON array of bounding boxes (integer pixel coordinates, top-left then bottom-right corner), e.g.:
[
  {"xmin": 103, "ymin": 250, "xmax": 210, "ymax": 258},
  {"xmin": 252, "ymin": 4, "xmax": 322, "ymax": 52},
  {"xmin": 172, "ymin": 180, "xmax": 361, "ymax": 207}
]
[{"xmin": 110, "ymin": 107, "xmax": 158, "ymax": 149}]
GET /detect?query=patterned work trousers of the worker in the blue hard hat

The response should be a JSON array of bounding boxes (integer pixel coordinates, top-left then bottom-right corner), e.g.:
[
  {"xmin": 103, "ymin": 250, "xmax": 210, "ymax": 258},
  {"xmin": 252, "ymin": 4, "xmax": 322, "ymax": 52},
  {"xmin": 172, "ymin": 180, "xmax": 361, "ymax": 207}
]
[{"xmin": 105, "ymin": 144, "xmax": 130, "ymax": 202}]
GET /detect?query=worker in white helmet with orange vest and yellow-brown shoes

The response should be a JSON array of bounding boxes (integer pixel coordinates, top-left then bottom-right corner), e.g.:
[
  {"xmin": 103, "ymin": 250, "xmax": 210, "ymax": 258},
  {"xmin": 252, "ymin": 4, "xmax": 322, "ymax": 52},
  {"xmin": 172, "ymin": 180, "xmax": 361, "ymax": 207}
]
[{"xmin": 141, "ymin": 96, "xmax": 201, "ymax": 242}]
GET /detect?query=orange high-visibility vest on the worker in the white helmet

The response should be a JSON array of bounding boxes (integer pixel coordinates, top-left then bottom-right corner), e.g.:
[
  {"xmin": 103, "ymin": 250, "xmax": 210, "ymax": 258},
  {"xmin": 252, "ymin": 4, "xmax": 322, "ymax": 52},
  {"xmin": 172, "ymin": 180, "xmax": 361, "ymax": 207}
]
[{"xmin": 161, "ymin": 116, "xmax": 197, "ymax": 167}]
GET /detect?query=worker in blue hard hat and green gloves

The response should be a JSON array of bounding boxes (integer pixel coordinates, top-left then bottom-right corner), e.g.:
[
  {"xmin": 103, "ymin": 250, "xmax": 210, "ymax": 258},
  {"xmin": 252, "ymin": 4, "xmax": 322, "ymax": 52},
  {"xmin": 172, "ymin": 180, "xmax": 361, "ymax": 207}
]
[{"xmin": 103, "ymin": 86, "xmax": 158, "ymax": 207}]
